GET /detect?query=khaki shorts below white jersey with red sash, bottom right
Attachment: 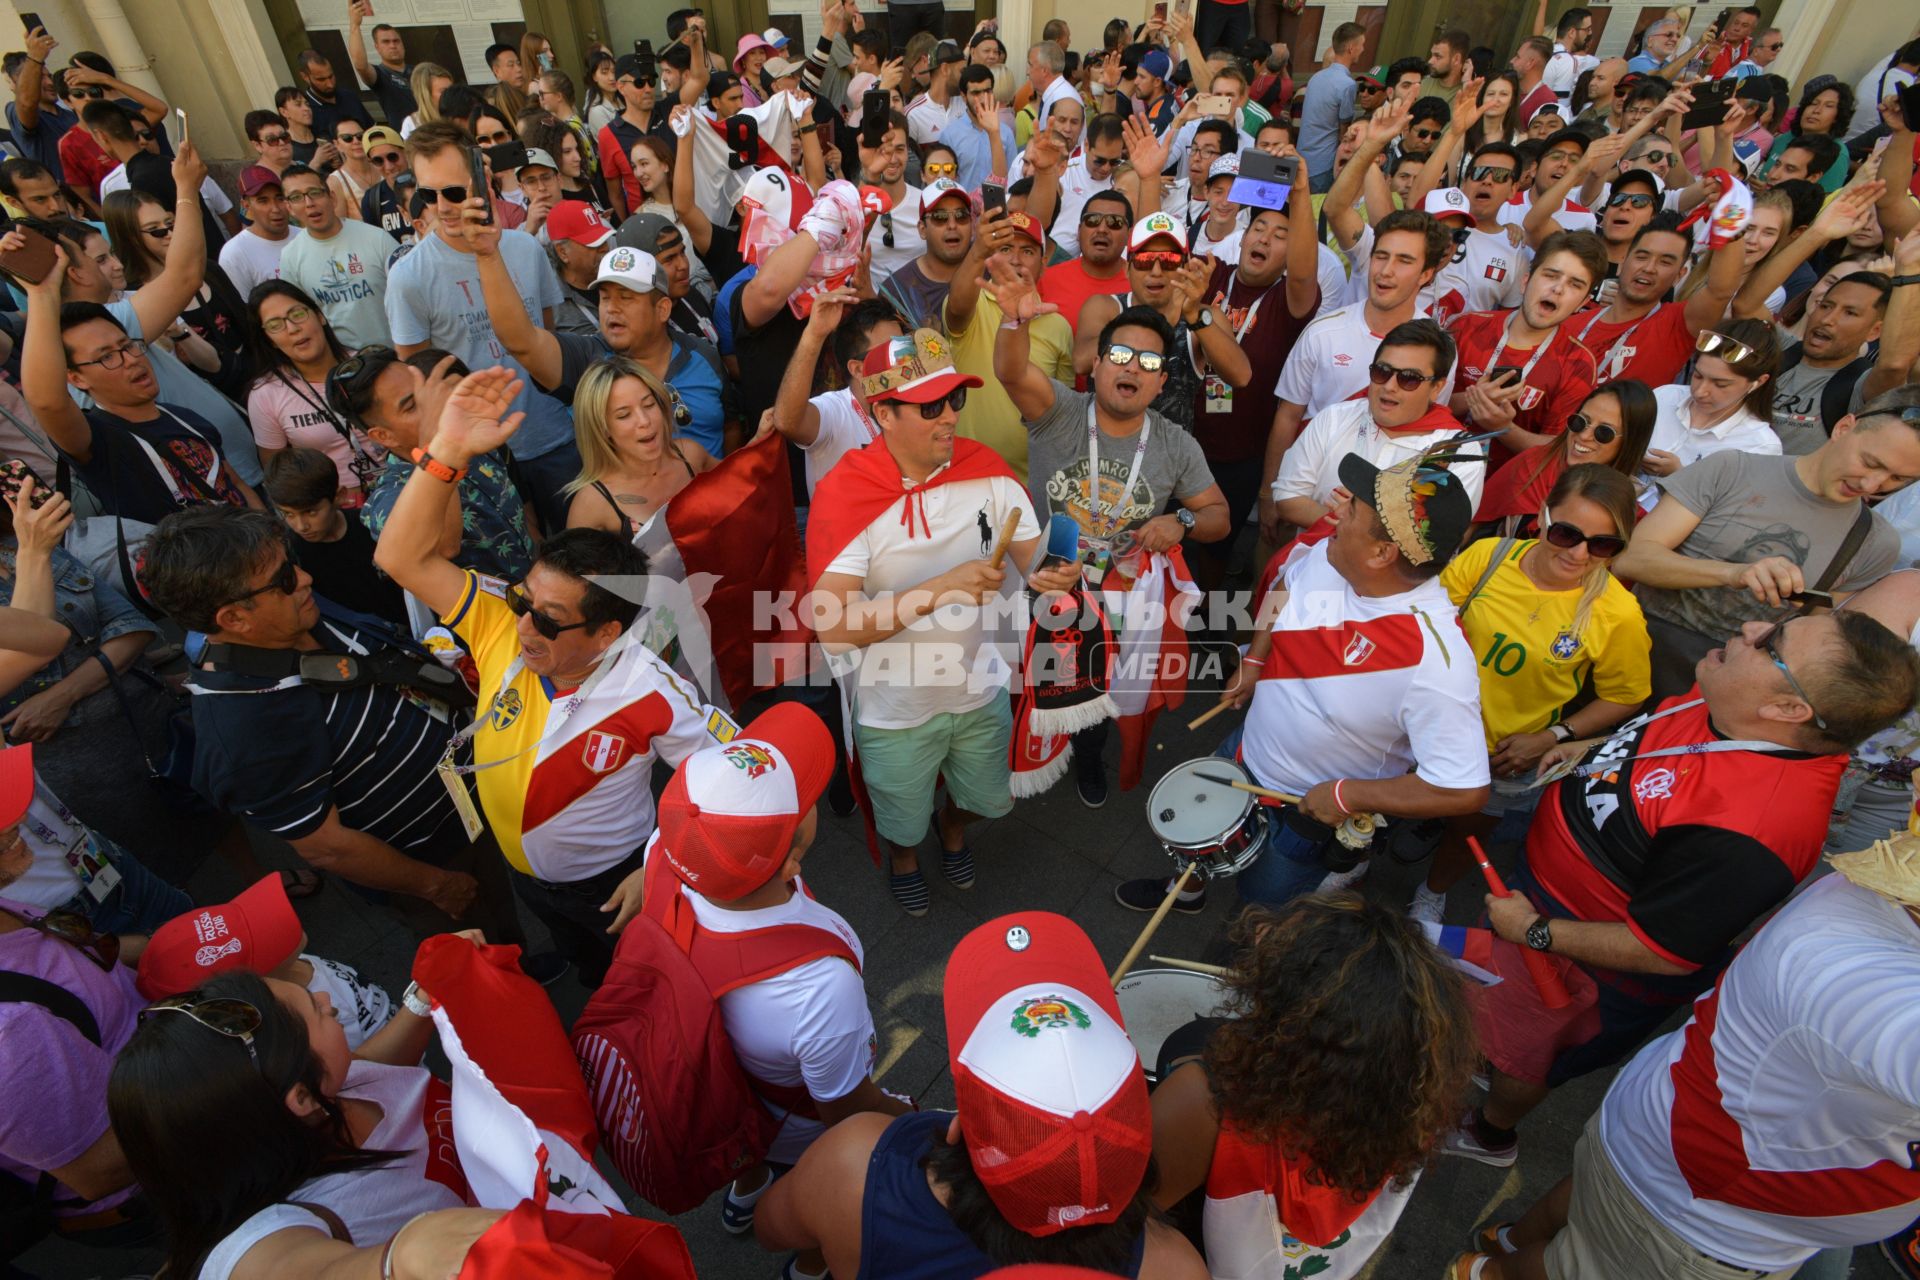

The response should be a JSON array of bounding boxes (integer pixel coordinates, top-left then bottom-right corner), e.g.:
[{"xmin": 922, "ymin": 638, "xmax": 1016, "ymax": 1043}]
[{"xmin": 1546, "ymin": 1111, "xmax": 1799, "ymax": 1280}]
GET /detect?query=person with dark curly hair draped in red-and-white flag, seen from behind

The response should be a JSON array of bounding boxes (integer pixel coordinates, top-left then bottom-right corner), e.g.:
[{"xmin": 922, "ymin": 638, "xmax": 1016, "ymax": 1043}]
[{"xmin": 1154, "ymin": 892, "xmax": 1480, "ymax": 1280}]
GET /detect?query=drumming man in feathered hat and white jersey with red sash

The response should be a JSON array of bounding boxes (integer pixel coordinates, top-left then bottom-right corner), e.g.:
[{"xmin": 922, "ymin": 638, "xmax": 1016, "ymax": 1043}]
[{"xmin": 1116, "ymin": 453, "xmax": 1490, "ymax": 912}]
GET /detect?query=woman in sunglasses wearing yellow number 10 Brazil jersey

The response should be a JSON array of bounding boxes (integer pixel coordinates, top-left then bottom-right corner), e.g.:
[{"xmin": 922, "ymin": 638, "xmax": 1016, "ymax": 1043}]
[{"xmin": 1411, "ymin": 462, "xmax": 1653, "ymax": 921}]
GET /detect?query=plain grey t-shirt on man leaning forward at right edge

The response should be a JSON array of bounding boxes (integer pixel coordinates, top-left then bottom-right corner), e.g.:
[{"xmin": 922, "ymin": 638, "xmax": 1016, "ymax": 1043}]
[{"xmin": 1636, "ymin": 449, "xmax": 1901, "ymax": 639}]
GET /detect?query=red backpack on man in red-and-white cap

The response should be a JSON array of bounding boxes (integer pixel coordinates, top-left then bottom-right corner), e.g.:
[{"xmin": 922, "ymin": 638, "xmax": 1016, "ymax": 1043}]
[{"xmin": 572, "ymin": 858, "xmax": 860, "ymax": 1215}]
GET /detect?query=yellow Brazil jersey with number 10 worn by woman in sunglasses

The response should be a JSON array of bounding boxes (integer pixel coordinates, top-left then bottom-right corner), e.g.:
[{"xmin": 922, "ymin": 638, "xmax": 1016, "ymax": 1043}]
[{"xmin": 1440, "ymin": 537, "xmax": 1653, "ymax": 750}]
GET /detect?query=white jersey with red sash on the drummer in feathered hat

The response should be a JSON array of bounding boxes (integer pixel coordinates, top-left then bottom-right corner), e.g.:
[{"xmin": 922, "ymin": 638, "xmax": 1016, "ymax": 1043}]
[{"xmin": 1240, "ymin": 541, "xmax": 1488, "ymax": 794}]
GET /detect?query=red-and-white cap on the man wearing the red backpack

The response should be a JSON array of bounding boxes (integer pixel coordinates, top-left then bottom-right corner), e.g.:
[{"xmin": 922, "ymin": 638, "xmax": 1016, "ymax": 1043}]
[{"xmin": 653, "ymin": 702, "xmax": 833, "ymax": 902}]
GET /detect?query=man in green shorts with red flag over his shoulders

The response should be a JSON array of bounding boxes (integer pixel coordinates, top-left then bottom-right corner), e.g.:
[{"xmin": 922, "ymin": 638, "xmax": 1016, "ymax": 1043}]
[{"xmin": 806, "ymin": 328, "xmax": 1075, "ymax": 915}]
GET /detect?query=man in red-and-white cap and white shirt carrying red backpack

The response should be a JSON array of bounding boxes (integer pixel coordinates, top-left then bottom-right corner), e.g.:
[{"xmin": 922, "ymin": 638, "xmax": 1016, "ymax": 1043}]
[{"xmin": 645, "ymin": 702, "xmax": 908, "ymax": 1243}]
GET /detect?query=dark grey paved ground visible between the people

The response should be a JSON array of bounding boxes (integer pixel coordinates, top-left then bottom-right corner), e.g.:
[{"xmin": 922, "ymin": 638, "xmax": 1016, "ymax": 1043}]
[{"xmin": 21, "ymin": 697, "xmax": 1893, "ymax": 1280}]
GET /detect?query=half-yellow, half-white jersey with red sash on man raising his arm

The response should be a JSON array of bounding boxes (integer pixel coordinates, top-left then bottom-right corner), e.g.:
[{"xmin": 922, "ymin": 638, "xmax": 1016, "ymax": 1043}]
[{"xmin": 444, "ymin": 570, "xmax": 737, "ymax": 883}]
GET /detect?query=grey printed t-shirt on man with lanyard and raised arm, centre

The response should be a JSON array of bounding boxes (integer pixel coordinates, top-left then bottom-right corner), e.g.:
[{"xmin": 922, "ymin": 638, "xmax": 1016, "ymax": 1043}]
[{"xmin": 1027, "ymin": 380, "xmax": 1213, "ymax": 537}]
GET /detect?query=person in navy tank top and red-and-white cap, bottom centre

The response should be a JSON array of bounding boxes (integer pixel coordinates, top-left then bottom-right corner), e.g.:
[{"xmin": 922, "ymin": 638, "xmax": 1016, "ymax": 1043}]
[{"xmin": 755, "ymin": 912, "xmax": 1206, "ymax": 1280}]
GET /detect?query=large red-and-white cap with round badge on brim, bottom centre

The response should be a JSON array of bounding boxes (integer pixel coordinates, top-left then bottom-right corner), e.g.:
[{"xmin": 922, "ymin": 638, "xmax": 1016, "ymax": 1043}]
[{"xmin": 945, "ymin": 912, "xmax": 1154, "ymax": 1236}]
